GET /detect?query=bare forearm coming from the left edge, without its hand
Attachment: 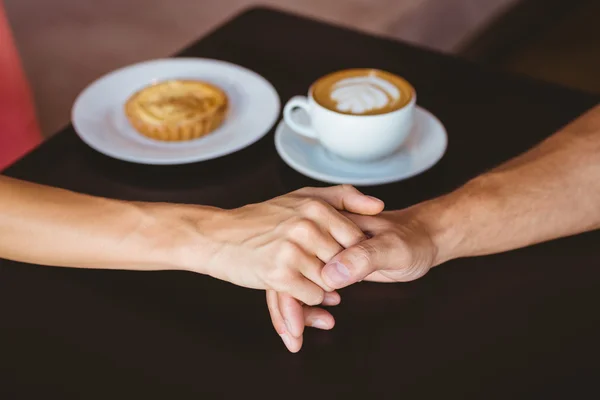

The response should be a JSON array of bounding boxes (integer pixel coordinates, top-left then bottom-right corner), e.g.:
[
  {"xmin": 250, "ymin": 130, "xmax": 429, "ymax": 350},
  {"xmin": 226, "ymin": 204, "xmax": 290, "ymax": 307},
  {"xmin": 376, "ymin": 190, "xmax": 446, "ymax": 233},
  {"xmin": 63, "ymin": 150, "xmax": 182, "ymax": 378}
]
[{"xmin": 0, "ymin": 176, "xmax": 211, "ymax": 270}]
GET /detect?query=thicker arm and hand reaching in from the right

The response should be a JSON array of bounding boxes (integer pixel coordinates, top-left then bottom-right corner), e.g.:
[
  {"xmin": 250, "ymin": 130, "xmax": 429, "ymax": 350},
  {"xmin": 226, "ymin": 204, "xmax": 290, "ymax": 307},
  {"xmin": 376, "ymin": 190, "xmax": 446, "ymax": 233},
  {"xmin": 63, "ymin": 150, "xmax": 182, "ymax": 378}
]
[{"xmin": 270, "ymin": 105, "xmax": 600, "ymax": 351}]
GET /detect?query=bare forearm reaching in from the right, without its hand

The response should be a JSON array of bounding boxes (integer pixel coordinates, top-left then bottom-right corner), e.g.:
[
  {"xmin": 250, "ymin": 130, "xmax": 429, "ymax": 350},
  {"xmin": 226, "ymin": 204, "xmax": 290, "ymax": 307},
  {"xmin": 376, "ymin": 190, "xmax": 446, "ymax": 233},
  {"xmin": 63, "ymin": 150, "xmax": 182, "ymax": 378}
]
[{"xmin": 410, "ymin": 107, "xmax": 600, "ymax": 264}]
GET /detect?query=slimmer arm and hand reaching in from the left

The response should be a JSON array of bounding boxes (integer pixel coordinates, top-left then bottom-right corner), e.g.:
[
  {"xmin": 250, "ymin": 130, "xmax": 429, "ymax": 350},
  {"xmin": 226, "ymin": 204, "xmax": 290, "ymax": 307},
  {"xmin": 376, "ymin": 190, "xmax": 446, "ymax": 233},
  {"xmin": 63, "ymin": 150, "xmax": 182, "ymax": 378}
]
[{"xmin": 0, "ymin": 176, "xmax": 383, "ymax": 354}]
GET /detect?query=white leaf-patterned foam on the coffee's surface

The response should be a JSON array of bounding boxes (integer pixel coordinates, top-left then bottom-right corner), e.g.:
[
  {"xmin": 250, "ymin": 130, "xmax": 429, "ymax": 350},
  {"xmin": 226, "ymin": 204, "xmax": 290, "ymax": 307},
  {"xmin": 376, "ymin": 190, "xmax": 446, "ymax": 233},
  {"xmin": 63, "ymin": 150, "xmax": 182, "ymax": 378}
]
[{"xmin": 331, "ymin": 76, "xmax": 401, "ymax": 114}]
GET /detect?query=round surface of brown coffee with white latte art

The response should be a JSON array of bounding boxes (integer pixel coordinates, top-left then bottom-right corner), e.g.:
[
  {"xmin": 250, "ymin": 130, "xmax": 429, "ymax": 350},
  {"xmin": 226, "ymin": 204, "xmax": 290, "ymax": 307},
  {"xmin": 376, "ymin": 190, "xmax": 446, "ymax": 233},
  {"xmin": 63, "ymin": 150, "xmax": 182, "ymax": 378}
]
[{"xmin": 311, "ymin": 69, "xmax": 415, "ymax": 115}]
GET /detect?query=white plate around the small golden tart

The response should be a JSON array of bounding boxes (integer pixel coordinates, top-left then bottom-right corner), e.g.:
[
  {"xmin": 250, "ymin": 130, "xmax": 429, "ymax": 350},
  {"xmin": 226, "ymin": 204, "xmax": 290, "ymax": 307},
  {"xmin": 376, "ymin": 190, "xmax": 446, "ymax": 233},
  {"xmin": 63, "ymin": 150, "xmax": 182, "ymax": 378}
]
[{"xmin": 72, "ymin": 58, "xmax": 280, "ymax": 164}]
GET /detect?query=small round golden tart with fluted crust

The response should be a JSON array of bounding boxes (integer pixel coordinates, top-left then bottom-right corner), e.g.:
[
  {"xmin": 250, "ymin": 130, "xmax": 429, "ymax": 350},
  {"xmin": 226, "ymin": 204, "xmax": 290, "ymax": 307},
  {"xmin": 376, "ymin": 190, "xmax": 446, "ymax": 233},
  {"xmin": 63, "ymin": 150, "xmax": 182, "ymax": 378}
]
[{"xmin": 125, "ymin": 80, "xmax": 228, "ymax": 141}]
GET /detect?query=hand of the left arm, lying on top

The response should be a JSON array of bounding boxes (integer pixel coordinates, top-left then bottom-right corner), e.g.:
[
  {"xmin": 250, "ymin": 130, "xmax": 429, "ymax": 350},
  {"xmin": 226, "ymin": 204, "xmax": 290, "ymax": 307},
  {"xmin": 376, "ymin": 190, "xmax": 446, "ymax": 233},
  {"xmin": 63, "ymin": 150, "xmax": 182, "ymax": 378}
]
[{"xmin": 178, "ymin": 186, "xmax": 383, "ymax": 305}]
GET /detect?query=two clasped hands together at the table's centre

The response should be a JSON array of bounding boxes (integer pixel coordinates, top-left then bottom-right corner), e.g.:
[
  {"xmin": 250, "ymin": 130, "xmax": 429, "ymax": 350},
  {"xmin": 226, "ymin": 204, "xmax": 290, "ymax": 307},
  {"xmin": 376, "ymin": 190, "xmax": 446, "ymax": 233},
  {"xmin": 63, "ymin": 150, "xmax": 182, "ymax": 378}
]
[{"xmin": 182, "ymin": 185, "xmax": 435, "ymax": 352}]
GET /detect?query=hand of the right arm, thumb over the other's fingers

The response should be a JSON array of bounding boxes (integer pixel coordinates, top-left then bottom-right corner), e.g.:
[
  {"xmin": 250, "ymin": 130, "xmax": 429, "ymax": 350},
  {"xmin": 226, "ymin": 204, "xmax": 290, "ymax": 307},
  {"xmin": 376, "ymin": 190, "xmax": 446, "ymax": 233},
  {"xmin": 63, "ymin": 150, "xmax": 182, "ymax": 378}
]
[{"xmin": 267, "ymin": 210, "xmax": 437, "ymax": 353}]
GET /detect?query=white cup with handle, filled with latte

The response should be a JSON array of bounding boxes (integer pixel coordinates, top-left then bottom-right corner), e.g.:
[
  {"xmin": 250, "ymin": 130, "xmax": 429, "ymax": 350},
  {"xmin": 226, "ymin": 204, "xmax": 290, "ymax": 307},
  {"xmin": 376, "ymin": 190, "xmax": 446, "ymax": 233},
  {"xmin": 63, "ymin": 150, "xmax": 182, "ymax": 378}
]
[{"xmin": 283, "ymin": 69, "xmax": 416, "ymax": 161}]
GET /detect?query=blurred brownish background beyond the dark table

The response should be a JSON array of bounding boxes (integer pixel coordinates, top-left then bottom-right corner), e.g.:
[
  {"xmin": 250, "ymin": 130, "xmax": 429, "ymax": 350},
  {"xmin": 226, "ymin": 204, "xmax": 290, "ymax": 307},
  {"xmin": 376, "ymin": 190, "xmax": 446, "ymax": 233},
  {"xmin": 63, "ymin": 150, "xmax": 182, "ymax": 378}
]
[{"xmin": 0, "ymin": 0, "xmax": 600, "ymax": 137}]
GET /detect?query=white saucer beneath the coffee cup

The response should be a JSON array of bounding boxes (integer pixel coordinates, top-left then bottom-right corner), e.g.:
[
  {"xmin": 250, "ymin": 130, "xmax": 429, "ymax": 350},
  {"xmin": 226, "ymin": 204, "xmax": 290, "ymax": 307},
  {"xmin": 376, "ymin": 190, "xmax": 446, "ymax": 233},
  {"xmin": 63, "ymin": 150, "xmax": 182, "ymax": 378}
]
[{"xmin": 275, "ymin": 106, "xmax": 448, "ymax": 185}]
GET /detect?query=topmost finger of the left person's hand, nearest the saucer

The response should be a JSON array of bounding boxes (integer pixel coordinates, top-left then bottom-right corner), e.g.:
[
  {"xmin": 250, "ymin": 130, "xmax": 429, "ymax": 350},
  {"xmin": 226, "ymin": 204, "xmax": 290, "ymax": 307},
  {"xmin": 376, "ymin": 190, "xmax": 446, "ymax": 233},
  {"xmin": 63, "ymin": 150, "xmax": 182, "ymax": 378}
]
[{"xmin": 296, "ymin": 185, "xmax": 385, "ymax": 215}]
